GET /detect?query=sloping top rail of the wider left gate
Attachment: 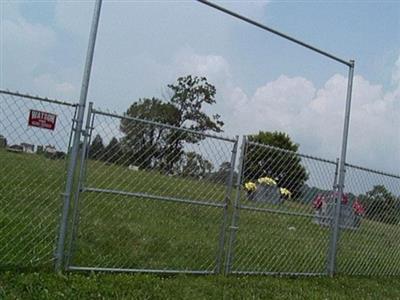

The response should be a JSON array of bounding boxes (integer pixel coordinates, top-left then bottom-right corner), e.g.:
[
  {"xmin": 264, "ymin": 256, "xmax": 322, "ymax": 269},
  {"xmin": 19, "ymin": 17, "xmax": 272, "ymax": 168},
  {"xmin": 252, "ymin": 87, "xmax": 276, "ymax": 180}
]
[{"xmin": 92, "ymin": 109, "xmax": 238, "ymax": 143}]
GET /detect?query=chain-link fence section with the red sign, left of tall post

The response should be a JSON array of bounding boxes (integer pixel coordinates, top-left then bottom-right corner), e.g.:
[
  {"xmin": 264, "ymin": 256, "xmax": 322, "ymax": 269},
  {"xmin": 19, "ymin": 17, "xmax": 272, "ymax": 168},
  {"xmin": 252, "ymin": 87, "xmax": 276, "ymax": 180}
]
[{"xmin": 0, "ymin": 91, "xmax": 76, "ymax": 269}]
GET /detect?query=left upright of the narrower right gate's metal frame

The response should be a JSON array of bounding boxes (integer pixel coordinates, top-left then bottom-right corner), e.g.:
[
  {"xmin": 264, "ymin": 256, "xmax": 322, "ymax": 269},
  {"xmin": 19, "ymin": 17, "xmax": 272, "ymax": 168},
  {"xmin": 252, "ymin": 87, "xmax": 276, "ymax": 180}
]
[{"xmin": 225, "ymin": 136, "xmax": 247, "ymax": 274}]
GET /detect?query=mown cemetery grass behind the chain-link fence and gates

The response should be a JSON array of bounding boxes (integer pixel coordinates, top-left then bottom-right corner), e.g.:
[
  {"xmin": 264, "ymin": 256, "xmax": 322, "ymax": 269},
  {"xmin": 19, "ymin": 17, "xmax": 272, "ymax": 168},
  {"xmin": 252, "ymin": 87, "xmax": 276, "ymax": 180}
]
[{"xmin": 0, "ymin": 151, "xmax": 400, "ymax": 276}]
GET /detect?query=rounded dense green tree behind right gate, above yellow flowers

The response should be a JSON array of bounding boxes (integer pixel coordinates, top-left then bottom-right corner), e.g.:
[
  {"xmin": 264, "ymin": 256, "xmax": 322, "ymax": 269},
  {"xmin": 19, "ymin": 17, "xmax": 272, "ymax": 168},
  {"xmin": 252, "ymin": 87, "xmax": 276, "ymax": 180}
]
[{"xmin": 244, "ymin": 131, "xmax": 308, "ymax": 198}]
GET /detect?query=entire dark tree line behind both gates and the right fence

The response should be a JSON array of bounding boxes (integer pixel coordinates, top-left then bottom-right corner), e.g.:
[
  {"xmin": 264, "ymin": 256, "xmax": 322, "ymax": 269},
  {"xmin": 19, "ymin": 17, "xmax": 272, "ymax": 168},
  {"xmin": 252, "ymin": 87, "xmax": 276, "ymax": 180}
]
[{"xmin": 83, "ymin": 75, "xmax": 399, "ymax": 224}]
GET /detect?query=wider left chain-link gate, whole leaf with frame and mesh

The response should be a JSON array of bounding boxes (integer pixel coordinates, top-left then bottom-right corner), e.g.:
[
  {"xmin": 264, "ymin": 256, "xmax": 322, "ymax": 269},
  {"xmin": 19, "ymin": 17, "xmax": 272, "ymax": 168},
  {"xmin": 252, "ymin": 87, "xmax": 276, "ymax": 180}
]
[{"xmin": 67, "ymin": 108, "xmax": 237, "ymax": 274}]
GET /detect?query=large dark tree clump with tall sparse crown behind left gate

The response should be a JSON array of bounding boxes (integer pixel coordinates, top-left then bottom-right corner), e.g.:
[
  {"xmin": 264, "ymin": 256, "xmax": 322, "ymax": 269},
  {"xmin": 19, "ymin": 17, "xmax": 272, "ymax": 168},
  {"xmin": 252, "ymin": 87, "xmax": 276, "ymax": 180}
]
[{"xmin": 120, "ymin": 75, "xmax": 223, "ymax": 172}]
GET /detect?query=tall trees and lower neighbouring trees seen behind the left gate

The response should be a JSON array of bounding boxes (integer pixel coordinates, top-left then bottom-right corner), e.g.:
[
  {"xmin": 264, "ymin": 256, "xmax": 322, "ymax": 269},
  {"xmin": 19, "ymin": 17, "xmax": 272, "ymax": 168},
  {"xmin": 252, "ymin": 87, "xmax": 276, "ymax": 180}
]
[{"xmin": 89, "ymin": 75, "xmax": 234, "ymax": 180}]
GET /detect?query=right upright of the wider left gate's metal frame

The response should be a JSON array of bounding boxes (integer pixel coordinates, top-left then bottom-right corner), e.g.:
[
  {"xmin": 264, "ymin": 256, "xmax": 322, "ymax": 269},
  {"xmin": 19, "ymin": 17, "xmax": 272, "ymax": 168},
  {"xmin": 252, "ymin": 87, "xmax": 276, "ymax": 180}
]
[{"xmin": 216, "ymin": 136, "xmax": 239, "ymax": 273}]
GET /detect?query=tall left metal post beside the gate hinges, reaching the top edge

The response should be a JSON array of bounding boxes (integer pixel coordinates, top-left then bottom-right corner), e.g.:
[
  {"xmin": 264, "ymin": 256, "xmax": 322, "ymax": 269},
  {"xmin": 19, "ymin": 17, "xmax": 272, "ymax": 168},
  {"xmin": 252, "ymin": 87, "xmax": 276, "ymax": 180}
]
[{"xmin": 55, "ymin": 0, "xmax": 102, "ymax": 272}]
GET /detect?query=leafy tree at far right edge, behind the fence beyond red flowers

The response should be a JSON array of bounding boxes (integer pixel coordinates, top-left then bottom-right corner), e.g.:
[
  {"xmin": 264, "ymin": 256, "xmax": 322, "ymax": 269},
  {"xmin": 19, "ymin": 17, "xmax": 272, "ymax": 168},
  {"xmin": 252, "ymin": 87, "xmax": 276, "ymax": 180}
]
[{"xmin": 359, "ymin": 185, "xmax": 400, "ymax": 224}]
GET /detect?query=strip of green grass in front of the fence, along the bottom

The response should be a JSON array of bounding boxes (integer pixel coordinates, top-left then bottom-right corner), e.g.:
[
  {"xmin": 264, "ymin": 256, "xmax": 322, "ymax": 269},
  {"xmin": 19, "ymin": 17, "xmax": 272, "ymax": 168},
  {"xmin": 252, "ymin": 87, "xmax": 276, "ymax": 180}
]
[{"xmin": 0, "ymin": 273, "xmax": 400, "ymax": 300}]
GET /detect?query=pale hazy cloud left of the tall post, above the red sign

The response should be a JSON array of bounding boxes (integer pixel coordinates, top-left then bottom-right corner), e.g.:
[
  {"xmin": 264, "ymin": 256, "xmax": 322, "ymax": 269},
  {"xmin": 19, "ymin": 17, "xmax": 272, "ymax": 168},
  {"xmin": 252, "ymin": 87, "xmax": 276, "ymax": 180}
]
[{"xmin": 1, "ymin": 1, "xmax": 77, "ymax": 99}]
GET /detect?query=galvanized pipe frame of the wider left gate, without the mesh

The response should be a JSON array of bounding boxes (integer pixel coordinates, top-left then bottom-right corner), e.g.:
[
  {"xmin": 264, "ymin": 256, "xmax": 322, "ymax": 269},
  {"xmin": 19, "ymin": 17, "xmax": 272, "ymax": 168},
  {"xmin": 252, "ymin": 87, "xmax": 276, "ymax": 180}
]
[{"xmin": 65, "ymin": 108, "xmax": 238, "ymax": 274}]
